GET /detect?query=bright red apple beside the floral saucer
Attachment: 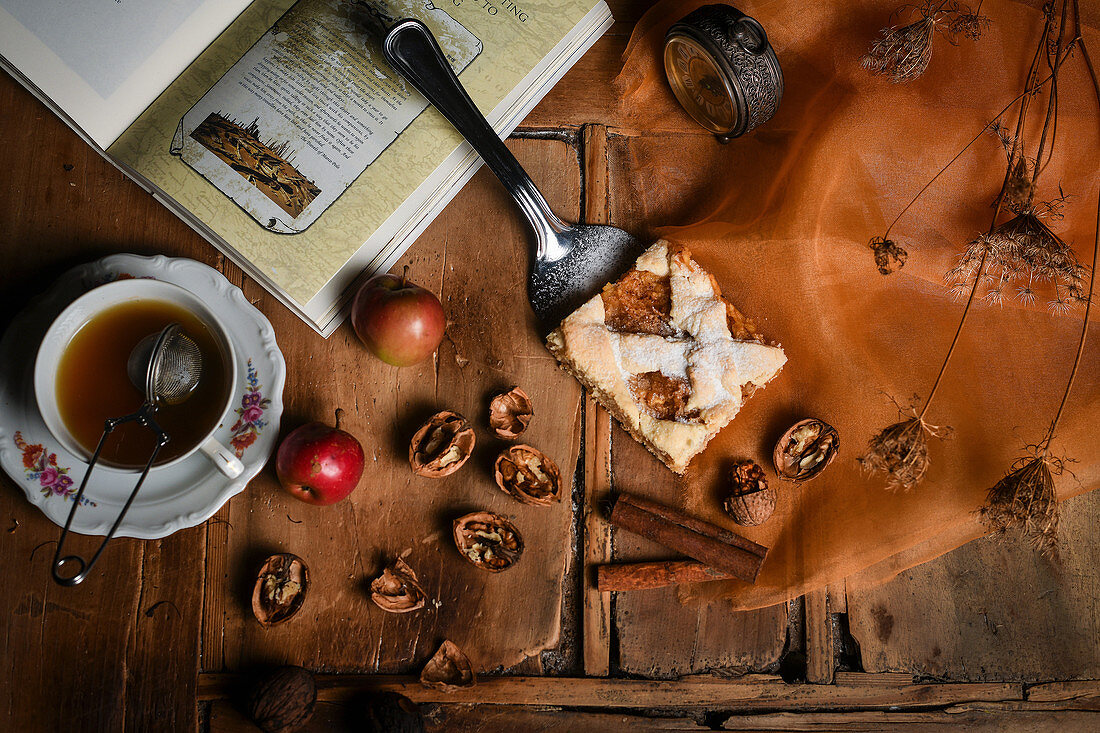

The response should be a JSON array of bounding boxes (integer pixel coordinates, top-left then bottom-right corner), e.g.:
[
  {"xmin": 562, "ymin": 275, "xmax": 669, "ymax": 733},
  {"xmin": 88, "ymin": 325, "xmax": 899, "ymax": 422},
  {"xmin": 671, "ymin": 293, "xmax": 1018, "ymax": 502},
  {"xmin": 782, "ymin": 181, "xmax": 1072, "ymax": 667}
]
[{"xmin": 275, "ymin": 409, "xmax": 364, "ymax": 506}]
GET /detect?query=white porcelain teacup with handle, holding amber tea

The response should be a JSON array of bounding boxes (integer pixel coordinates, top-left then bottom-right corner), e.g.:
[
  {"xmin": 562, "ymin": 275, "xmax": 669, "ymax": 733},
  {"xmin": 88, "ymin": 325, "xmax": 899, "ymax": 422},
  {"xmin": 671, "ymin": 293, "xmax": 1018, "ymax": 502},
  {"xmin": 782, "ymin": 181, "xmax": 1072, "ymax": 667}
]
[{"xmin": 34, "ymin": 278, "xmax": 244, "ymax": 479}]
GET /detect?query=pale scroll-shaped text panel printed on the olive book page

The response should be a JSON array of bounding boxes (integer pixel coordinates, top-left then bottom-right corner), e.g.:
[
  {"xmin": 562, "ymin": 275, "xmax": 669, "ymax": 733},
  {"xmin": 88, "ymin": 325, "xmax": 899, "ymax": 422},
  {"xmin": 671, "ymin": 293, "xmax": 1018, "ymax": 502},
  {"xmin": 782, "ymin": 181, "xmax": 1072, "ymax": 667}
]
[{"xmin": 171, "ymin": 0, "xmax": 483, "ymax": 233}]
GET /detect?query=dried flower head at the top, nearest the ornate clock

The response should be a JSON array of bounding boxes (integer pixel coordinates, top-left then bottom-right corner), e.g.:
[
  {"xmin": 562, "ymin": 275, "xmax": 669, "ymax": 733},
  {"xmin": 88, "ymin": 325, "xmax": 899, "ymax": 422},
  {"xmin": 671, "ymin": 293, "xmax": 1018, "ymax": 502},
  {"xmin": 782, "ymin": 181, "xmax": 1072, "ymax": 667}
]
[{"xmin": 861, "ymin": 2, "xmax": 990, "ymax": 84}]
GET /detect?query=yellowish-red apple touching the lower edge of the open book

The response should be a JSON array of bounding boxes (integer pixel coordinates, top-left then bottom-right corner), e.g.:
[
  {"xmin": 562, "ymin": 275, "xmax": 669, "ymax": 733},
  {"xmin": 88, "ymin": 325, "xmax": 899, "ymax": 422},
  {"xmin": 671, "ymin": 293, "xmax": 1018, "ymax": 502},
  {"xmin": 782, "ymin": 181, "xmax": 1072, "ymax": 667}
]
[{"xmin": 351, "ymin": 267, "xmax": 447, "ymax": 367}]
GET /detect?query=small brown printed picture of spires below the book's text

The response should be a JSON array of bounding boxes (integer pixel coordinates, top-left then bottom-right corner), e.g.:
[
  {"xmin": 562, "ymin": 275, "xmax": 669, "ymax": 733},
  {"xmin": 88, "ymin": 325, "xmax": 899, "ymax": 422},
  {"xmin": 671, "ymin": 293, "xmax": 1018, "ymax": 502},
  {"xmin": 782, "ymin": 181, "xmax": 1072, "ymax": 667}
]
[{"xmin": 190, "ymin": 112, "xmax": 321, "ymax": 217}]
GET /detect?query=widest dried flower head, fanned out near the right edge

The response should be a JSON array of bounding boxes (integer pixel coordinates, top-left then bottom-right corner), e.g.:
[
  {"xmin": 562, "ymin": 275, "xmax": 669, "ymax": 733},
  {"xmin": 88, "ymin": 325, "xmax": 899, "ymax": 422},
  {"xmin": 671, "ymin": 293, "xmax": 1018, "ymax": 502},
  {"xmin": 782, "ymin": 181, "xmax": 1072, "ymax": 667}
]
[{"xmin": 945, "ymin": 205, "xmax": 1089, "ymax": 313}]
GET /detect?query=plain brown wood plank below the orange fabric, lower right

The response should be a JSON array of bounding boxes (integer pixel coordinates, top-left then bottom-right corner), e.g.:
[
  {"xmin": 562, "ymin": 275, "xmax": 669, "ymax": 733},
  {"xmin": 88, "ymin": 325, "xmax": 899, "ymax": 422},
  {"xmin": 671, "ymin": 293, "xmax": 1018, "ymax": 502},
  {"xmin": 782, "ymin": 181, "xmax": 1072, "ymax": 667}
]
[{"xmin": 848, "ymin": 484, "xmax": 1100, "ymax": 681}]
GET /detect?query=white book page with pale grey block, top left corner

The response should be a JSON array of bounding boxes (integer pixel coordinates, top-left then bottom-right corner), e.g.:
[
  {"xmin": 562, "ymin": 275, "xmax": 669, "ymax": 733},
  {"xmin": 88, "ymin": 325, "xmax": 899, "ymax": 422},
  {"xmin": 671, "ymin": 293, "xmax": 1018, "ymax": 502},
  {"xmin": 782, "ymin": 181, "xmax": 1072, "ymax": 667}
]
[{"xmin": 0, "ymin": 0, "xmax": 249, "ymax": 147}]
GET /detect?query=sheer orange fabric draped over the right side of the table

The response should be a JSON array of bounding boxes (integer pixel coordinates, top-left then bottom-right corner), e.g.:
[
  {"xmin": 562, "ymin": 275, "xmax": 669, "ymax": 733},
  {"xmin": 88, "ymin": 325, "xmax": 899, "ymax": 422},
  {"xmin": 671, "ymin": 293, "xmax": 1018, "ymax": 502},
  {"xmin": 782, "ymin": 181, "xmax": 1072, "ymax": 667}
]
[{"xmin": 616, "ymin": 0, "xmax": 1100, "ymax": 609}]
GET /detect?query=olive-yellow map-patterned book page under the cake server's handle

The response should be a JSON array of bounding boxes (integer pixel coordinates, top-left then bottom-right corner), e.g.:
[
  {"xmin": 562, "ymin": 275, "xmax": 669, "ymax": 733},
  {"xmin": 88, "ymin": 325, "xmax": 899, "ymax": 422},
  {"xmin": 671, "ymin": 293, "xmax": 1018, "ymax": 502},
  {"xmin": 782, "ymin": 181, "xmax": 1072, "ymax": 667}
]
[{"xmin": 108, "ymin": 0, "xmax": 606, "ymax": 311}]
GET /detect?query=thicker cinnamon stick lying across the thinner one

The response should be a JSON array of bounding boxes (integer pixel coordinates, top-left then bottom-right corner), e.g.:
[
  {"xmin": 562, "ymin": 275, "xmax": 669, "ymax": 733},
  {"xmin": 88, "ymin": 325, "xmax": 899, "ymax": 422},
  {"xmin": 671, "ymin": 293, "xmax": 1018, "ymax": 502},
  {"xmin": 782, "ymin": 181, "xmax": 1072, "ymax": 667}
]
[{"xmin": 609, "ymin": 494, "xmax": 768, "ymax": 582}]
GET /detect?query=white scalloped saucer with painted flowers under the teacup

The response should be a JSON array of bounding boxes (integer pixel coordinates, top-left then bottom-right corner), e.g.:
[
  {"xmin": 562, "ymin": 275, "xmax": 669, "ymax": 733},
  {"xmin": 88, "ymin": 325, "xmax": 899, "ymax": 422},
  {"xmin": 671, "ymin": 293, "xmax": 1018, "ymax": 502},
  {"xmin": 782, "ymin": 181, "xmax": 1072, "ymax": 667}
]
[{"xmin": 0, "ymin": 254, "xmax": 286, "ymax": 539}]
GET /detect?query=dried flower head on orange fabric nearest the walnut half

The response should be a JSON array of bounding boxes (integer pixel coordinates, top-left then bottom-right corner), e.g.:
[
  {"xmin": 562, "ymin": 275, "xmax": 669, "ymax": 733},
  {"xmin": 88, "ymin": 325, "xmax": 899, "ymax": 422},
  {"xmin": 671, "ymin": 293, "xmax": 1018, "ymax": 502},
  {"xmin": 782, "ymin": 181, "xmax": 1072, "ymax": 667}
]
[{"xmin": 858, "ymin": 395, "xmax": 953, "ymax": 491}]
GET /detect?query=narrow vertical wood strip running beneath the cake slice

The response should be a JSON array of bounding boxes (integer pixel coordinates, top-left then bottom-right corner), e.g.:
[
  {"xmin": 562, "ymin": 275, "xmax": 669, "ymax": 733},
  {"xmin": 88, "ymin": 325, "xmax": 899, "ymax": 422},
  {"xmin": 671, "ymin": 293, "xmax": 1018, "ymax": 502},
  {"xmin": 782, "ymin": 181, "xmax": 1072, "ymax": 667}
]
[{"xmin": 582, "ymin": 124, "xmax": 612, "ymax": 676}]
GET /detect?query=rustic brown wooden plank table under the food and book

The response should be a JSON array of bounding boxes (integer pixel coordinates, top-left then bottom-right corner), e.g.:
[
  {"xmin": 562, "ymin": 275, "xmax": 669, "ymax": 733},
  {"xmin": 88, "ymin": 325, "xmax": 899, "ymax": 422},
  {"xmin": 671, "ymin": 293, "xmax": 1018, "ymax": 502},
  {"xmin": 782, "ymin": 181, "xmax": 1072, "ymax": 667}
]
[{"xmin": 0, "ymin": 0, "xmax": 1100, "ymax": 731}]
